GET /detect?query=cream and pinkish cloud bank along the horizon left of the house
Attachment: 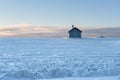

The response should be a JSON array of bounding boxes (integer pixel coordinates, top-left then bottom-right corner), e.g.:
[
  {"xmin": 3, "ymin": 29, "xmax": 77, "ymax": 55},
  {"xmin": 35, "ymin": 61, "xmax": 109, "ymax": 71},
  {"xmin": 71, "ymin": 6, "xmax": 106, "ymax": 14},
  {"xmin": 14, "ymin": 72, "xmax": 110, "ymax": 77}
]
[{"xmin": 0, "ymin": 25, "xmax": 68, "ymax": 37}]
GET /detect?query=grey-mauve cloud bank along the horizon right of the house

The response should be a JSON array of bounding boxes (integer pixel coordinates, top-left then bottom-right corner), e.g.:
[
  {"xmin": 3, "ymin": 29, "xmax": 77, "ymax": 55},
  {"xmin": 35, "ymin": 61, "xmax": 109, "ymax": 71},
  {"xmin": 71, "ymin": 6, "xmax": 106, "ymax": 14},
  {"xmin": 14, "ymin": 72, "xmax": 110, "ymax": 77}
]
[{"xmin": 84, "ymin": 27, "xmax": 120, "ymax": 37}]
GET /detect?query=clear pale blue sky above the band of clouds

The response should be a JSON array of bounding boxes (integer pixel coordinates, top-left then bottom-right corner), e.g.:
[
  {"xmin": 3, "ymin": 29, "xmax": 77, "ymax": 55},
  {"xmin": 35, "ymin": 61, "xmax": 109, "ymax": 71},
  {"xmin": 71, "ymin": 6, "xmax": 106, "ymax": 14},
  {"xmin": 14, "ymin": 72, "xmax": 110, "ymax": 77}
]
[{"xmin": 0, "ymin": 0, "xmax": 120, "ymax": 27}]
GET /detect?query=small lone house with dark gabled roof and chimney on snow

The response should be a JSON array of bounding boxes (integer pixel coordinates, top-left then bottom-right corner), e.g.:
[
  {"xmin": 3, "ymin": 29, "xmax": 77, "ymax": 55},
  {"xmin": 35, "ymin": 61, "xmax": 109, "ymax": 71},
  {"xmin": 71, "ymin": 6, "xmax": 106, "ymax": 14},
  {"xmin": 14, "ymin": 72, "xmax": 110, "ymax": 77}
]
[{"xmin": 68, "ymin": 25, "xmax": 82, "ymax": 38}]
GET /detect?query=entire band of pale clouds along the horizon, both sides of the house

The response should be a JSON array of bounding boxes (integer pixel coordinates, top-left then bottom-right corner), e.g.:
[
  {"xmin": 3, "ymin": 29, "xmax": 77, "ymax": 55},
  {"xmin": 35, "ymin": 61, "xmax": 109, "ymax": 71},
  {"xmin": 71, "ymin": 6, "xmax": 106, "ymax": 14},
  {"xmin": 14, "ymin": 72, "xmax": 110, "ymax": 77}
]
[{"xmin": 0, "ymin": 24, "xmax": 120, "ymax": 38}]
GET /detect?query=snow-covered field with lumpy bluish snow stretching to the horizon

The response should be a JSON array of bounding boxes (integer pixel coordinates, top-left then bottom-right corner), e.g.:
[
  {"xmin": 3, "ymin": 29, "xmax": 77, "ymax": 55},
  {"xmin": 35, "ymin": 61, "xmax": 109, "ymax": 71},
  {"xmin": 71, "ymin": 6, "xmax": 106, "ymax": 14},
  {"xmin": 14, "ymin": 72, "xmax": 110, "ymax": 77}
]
[{"xmin": 0, "ymin": 38, "xmax": 120, "ymax": 80}]
